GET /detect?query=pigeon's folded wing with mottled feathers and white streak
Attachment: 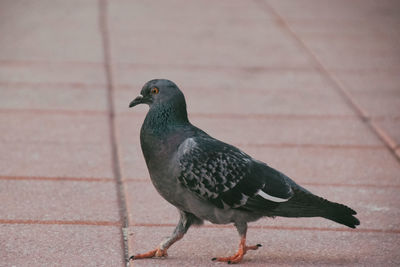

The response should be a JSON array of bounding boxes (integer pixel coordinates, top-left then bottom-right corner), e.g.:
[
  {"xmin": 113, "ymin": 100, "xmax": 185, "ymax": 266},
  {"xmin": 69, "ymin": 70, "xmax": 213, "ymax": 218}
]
[{"xmin": 177, "ymin": 137, "xmax": 292, "ymax": 210}]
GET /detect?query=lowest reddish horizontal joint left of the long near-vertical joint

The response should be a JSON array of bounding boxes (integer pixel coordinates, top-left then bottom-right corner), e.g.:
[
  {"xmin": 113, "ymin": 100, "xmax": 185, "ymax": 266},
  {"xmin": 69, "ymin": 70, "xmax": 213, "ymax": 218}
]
[{"xmin": 0, "ymin": 219, "xmax": 121, "ymax": 226}]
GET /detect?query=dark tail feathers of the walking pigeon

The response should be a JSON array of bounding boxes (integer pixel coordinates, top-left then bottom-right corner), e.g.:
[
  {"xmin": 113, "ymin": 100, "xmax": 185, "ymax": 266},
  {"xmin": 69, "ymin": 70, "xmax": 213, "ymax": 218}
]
[{"xmin": 273, "ymin": 188, "xmax": 360, "ymax": 228}]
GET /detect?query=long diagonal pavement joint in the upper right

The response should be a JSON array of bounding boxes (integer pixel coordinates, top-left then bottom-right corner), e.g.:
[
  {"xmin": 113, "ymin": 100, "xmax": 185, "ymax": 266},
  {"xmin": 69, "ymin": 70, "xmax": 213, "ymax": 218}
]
[{"xmin": 258, "ymin": 0, "xmax": 400, "ymax": 163}]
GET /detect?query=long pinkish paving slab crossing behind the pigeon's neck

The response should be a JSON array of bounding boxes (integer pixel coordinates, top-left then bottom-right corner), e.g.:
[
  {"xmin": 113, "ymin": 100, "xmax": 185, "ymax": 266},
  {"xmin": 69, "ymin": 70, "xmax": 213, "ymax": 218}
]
[{"xmin": 118, "ymin": 110, "xmax": 383, "ymax": 146}]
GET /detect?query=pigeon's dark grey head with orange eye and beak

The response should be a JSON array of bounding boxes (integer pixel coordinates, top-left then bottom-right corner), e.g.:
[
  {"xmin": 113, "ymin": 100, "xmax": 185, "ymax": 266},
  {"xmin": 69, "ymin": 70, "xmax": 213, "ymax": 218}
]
[{"xmin": 129, "ymin": 79, "xmax": 186, "ymax": 109}]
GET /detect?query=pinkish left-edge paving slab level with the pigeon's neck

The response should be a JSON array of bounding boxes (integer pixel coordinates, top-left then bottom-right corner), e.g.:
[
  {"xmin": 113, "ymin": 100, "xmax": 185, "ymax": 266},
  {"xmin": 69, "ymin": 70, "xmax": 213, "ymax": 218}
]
[{"xmin": 0, "ymin": 110, "xmax": 110, "ymax": 146}]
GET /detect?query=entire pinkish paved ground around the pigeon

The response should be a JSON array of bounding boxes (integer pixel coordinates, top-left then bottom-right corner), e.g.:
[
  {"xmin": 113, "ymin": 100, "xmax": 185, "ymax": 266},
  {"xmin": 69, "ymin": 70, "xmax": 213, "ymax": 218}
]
[{"xmin": 0, "ymin": 0, "xmax": 400, "ymax": 266}]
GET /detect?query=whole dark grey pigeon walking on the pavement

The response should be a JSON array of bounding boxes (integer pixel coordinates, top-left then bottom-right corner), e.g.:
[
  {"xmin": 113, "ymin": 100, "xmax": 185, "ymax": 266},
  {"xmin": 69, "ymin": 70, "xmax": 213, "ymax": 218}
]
[{"xmin": 129, "ymin": 79, "xmax": 360, "ymax": 264}]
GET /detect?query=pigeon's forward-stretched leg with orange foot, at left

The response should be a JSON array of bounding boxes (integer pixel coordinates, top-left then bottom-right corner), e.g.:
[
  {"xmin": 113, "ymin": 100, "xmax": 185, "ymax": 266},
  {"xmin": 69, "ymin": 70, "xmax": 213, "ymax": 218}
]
[{"xmin": 129, "ymin": 211, "xmax": 194, "ymax": 260}]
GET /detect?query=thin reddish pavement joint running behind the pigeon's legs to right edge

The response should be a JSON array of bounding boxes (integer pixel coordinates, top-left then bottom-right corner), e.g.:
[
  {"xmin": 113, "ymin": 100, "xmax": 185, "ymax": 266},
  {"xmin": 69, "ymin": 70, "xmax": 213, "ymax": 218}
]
[{"xmin": 130, "ymin": 223, "xmax": 400, "ymax": 234}]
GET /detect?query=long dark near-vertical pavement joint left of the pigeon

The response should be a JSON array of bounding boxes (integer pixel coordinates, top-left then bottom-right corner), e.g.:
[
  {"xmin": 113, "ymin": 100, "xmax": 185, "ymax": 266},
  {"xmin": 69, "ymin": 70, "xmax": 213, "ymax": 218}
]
[{"xmin": 97, "ymin": 0, "xmax": 129, "ymax": 266}]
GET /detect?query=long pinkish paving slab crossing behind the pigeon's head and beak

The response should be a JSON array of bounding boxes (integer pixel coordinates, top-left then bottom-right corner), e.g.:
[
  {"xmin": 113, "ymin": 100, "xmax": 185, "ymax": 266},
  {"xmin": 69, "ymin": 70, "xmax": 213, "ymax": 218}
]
[{"xmin": 115, "ymin": 85, "xmax": 354, "ymax": 116}]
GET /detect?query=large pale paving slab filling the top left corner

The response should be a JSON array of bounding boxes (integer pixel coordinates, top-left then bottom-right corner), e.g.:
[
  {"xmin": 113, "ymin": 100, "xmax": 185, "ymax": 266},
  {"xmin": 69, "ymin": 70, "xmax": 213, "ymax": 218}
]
[{"xmin": 0, "ymin": 0, "xmax": 103, "ymax": 62}]
